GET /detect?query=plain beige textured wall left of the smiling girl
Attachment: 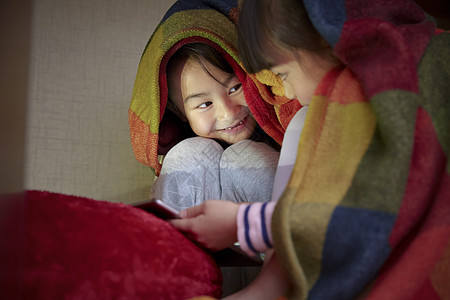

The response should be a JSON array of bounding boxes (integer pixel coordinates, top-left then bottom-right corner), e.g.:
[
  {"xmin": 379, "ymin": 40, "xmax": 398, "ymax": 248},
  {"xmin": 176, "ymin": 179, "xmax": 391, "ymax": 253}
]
[{"xmin": 25, "ymin": 0, "xmax": 174, "ymax": 203}]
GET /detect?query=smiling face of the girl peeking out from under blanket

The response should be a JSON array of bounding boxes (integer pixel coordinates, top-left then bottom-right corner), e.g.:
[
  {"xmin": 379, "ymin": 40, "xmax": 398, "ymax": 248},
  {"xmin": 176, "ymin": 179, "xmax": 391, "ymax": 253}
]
[{"xmin": 169, "ymin": 57, "xmax": 256, "ymax": 144}]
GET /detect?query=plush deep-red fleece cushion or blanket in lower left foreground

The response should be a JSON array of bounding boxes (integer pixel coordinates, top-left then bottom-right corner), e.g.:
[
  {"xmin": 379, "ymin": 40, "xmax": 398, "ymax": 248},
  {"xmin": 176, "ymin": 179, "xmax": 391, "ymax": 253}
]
[{"xmin": 22, "ymin": 191, "xmax": 222, "ymax": 300}]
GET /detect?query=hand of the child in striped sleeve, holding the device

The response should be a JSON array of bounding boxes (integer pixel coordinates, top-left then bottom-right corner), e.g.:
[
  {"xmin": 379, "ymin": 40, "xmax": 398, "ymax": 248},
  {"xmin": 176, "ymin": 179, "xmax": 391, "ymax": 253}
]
[{"xmin": 170, "ymin": 200, "xmax": 239, "ymax": 251}]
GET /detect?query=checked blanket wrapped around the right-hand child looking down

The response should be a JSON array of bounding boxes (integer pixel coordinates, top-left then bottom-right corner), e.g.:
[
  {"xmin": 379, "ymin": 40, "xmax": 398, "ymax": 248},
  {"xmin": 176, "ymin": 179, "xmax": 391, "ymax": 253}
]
[{"xmin": 272, "ymin": 0, "xmax": 450, "ymax": 299}]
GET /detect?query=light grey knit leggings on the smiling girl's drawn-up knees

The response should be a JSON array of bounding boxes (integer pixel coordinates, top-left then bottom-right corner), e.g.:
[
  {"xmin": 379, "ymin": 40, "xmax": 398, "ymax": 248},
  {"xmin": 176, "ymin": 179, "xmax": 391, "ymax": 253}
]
[{"xmin": 151, "ymin": 137, "xmax": 279, "ymax": 210}]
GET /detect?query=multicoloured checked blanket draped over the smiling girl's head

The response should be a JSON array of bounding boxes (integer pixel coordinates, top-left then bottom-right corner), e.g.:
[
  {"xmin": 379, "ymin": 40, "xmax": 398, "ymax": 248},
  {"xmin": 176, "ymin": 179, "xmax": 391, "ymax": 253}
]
[{"xmin": 129, "ymin": 0, "xmax": 299, "ymax": 175}]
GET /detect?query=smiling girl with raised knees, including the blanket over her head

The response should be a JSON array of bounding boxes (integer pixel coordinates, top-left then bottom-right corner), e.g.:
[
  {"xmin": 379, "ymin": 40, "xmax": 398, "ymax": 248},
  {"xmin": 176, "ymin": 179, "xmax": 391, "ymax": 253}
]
[{"xmin": 129, "ymin": 0, "xmax": 293, "ymax": 216}]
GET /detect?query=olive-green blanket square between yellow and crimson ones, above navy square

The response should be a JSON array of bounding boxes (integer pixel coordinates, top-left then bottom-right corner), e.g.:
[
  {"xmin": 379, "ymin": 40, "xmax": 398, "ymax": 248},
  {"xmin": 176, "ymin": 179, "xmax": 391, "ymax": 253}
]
[{"xmin": 341, "ymin": 90, "xmax": 419, "ymax": 214}]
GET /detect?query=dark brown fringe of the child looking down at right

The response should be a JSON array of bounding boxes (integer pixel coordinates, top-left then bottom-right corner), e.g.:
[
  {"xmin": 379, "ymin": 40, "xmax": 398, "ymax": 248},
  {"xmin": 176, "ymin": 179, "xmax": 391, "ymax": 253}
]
[{"xmin": 238, "ymin": 0, "xmax": 331, "ymax": 73}]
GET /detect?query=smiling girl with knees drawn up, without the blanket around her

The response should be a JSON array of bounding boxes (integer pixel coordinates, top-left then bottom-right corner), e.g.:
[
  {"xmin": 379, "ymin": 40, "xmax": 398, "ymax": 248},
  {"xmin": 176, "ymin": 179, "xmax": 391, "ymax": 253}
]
[{"xmin": 152, "ymin": 43, "xmax": 279, "ymax": 210}]
